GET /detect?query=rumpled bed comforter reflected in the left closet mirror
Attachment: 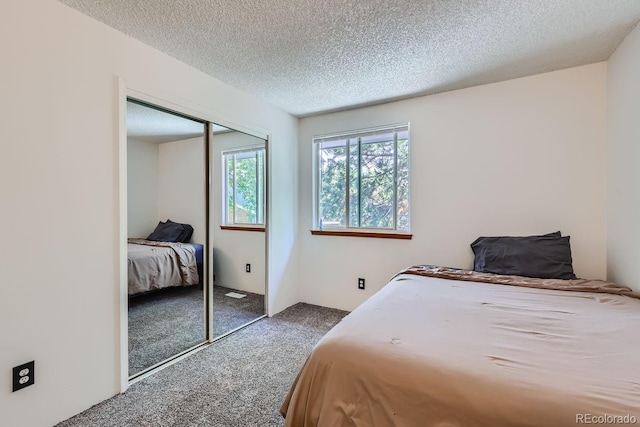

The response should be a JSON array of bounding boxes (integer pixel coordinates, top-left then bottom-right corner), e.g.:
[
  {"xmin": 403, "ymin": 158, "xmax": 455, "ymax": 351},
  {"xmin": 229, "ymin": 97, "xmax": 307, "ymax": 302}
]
[{"xmin": 127, "ymin": 239, "xmax": 199, "ymax": 295}]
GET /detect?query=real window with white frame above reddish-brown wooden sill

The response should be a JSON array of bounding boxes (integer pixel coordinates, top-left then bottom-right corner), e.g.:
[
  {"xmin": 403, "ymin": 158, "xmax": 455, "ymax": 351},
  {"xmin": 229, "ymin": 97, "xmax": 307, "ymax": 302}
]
[{"xmin": 313, "ymin": 124, "xmax": 410, "ymax": 233}]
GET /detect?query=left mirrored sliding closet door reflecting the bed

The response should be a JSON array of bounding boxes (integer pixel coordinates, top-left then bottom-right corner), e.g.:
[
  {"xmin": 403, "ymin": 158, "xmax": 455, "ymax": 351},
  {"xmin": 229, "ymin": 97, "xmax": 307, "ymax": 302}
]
[{"xmin": 127, "ymin": 99, "xmax": 208, "ymax": 377}]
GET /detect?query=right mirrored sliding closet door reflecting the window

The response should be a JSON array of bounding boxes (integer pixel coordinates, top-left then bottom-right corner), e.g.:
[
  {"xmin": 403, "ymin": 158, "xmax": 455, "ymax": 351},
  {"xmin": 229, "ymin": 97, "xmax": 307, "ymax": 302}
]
[{"xmin": 211, "ymin": 124, "xmax": 267, "ymax": 338}]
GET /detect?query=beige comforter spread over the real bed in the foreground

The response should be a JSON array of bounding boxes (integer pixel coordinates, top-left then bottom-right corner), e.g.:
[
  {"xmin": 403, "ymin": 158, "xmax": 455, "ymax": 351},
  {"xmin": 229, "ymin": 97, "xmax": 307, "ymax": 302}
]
[{"xmin": 281, "ymin": 267, "xmax": 640, "ymax": 427}]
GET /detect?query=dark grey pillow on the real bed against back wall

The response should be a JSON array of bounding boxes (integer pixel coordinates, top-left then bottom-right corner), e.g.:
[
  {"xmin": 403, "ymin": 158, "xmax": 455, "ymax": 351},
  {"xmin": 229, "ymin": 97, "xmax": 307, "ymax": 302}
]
[{"xmin": 471, "ymin": 232, "xmax": 576, "ymax": 279}]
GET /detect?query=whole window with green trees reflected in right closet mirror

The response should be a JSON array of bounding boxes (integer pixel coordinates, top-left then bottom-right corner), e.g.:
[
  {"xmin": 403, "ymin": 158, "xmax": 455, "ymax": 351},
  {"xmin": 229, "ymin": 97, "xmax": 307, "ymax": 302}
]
[{"xmin": 222, "ymin": 146, "xmax": 265, "ymax": 225}]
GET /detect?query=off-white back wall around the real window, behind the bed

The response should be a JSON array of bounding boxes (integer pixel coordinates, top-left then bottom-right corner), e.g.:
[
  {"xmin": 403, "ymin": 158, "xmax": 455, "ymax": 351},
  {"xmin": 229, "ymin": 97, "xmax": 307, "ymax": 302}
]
[{"xmin": 299, "ymin": 63, "xmax": 607, "ymax": 309}]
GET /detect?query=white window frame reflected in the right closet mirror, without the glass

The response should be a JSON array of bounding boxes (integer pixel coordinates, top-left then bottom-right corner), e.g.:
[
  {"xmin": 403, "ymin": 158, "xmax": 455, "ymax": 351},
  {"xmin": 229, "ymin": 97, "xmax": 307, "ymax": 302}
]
[{"xmin": 220, "ymin": 143, "xmax": 267, "ymax": 231}]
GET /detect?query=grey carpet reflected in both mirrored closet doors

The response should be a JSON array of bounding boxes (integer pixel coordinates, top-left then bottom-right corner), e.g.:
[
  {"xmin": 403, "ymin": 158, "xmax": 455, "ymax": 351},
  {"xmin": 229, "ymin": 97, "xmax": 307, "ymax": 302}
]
[{"xmin": 129, "ymin": 286, "xmax": 264, "ymax": 375}]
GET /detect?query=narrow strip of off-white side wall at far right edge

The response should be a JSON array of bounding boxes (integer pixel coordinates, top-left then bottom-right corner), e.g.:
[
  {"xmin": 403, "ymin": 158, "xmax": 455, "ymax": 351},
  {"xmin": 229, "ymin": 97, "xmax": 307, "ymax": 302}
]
[{"xmin": 607, "ymin": 22, "xmax": 640, "ymax": 291}]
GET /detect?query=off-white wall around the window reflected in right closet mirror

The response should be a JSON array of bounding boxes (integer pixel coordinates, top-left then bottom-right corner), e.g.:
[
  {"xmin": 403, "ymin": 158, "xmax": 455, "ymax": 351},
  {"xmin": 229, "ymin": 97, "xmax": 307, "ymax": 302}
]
[{"xmin": 211, "ymin": 132, "xmax": 266, "ymax": 294}]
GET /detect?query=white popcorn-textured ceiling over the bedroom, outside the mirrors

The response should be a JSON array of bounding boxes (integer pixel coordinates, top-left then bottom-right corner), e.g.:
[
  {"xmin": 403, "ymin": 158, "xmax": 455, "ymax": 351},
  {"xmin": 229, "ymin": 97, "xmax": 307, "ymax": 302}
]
[{"xmin": 60, "ymin": 0, "xmax": 640, "ymax": 117}]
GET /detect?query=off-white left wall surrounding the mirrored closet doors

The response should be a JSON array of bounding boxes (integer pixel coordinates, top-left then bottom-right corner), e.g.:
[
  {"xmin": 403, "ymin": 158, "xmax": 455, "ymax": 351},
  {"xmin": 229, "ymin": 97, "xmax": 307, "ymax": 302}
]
[{"xmin": 0, "ymin": 0, "xmax": 297, "ymax": 427}]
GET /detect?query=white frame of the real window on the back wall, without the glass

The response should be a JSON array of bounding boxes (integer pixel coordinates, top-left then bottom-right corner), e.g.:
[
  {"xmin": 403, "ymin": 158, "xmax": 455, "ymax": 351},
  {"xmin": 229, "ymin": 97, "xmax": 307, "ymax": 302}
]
[{"xmin": 311, "ymin": 122, "xmax": 412, "ymax": 239}]
